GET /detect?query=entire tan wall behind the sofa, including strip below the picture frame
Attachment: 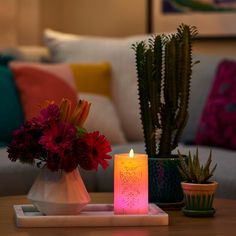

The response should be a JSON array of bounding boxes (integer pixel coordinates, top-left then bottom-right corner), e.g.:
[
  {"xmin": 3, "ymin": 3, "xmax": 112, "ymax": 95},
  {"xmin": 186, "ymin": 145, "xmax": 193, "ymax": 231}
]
[{"xmin": 0, "ymin": 0, "xmax": 236, "ymax": 54}]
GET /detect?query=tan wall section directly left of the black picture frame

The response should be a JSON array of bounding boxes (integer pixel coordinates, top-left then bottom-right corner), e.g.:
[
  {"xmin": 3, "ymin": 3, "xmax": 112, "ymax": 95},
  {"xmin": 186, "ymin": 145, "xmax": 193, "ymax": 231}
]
[{"xmin": 41, "ymin": 0, "xmax": 146, "ymax": 37}]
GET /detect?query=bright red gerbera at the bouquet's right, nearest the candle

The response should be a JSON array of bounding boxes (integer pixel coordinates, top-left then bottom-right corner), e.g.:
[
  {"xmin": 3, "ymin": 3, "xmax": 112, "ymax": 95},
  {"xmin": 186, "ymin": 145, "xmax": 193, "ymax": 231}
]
[{"xmin": 76, "ymin": 131, "xmax": 111, "ymax": 170}]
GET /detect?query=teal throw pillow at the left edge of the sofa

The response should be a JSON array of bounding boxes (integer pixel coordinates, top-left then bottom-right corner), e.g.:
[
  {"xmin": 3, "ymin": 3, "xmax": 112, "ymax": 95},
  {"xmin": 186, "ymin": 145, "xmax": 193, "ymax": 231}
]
[{"xmin": 0, "ymin": 66, "xmax": 24, "ymax": 146}]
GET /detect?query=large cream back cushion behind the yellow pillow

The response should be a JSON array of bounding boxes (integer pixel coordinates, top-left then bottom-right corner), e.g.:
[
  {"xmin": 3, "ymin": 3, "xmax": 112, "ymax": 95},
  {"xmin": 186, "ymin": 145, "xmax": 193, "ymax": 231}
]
[{"xmin": 44, "ymin": 29, "xmax": 150, "ymax": 141}]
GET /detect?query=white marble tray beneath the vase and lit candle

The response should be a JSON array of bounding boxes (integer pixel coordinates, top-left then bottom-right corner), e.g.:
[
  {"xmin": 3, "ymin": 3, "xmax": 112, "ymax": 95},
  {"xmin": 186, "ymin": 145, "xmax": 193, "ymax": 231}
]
[{"xmin": 13, "ymin": 204, "xmax": 169, "ymax": 227}]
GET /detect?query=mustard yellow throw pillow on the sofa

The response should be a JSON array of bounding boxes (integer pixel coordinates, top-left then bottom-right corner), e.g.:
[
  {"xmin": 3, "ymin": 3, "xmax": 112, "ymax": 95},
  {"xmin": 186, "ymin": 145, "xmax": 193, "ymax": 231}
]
[{"xmin": 70, "ymin": 63, "xmax": 111, "ymax": 97}]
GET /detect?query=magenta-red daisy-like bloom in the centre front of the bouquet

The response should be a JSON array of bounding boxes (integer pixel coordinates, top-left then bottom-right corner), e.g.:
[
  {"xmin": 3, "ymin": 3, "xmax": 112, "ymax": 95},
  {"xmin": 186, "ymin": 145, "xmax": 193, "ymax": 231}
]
[{"xmin": 39, "ymin": 123, "xmax": 76, "ymax": 154}]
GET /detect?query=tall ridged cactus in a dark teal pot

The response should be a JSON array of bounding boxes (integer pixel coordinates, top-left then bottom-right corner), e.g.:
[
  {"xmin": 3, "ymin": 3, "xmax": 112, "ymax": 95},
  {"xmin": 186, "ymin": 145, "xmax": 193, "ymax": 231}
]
[{"xmin": 133, "ymin": 24, "xmax": 197, "ymax": 206}]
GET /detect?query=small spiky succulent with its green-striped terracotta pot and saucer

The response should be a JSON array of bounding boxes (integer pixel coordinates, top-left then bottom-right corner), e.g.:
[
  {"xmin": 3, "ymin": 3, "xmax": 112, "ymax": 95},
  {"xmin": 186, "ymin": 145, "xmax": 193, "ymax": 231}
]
[{"xmin": 179, "ymin": 149, "xmax": 218, "ymax": 216}]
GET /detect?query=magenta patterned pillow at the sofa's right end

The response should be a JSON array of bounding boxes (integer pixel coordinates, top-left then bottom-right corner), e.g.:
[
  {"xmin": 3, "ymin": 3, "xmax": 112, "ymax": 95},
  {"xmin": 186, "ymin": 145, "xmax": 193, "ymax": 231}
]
[{"xmin": 196, "ymin": 60, "xmax": 236, "ymax": 149}]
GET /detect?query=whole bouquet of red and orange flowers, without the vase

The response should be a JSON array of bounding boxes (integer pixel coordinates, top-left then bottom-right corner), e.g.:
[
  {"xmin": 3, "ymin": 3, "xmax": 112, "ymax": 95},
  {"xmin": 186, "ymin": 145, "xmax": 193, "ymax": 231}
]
[{"xmin": 7, "ymin": 100, "xmax": 111, "ymax": 172}]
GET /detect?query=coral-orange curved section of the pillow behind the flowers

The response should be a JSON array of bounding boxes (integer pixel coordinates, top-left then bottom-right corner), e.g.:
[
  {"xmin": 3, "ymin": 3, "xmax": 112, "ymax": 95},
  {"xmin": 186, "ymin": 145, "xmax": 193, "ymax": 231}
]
[{"xmin": 11, "ymin": 66, "xmax": 77, "ymax": 120}]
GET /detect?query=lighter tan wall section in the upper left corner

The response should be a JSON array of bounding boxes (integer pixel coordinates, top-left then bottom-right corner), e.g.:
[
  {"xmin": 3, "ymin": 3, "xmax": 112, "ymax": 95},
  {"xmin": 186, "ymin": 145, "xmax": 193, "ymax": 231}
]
[{"xmin": 0, "ymin": 0, "xmax": 40, "ymax": 47}]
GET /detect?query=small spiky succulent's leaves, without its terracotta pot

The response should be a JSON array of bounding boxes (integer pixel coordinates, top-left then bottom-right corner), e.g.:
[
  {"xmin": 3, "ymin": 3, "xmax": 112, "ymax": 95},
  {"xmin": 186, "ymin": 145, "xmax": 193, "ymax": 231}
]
[{"xmin": 178, "ymin": 149, "xmax": 217, "ymax": 184}]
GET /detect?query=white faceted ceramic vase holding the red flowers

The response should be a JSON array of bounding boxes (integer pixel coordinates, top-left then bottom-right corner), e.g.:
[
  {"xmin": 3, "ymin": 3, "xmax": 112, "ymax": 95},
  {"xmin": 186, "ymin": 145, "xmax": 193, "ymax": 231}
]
[{"xmin": 27, "ymin": 168, "xmax": 90, "ymax": 215}]
